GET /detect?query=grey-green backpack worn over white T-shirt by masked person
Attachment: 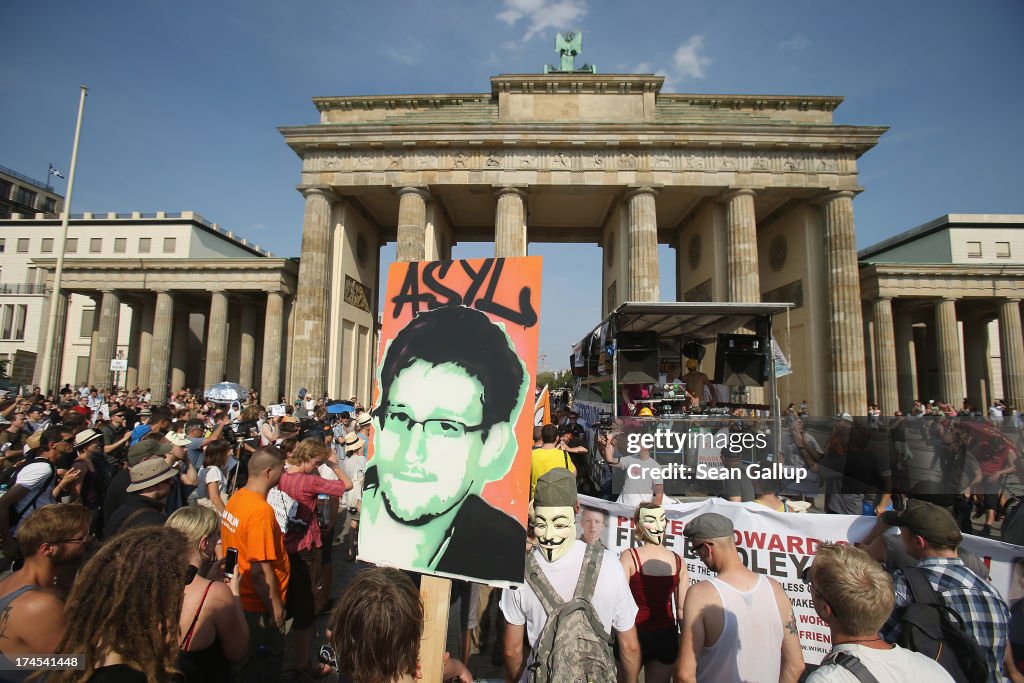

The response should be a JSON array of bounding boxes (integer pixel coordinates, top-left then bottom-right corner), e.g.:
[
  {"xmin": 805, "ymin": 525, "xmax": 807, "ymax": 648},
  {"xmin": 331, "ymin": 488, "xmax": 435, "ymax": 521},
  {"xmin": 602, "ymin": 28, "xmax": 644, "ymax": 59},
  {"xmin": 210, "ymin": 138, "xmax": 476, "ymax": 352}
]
[{"xmin": 526, "ymin": 544, "xmax": 615, "ymax": 683}]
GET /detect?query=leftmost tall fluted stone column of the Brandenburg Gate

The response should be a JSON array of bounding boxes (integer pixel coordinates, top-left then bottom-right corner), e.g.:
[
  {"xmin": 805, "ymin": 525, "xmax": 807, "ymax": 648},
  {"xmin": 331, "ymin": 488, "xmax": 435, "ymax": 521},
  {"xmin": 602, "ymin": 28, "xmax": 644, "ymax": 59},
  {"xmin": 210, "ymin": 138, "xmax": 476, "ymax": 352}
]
[{"xmin": 289, "ymin": 187, "xmax": 336, "ymax": 396}]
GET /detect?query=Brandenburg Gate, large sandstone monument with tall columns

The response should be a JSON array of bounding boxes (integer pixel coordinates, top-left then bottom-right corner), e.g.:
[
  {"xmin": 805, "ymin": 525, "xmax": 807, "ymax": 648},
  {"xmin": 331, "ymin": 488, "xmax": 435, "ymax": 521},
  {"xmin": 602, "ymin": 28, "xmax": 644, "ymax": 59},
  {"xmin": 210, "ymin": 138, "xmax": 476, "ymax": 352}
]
[{"xmin": 281, "ymin": 73, "xmax": 886, "ymax": 415}]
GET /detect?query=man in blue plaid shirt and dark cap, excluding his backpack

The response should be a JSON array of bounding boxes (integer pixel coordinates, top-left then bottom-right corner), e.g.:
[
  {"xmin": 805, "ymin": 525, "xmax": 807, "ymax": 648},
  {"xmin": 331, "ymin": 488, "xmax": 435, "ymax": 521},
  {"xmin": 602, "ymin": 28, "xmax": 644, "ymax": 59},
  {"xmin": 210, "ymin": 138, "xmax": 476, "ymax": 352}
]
[{"xmin": 882, "ymin": 500, "xmax": 1010, "ymax": 683}]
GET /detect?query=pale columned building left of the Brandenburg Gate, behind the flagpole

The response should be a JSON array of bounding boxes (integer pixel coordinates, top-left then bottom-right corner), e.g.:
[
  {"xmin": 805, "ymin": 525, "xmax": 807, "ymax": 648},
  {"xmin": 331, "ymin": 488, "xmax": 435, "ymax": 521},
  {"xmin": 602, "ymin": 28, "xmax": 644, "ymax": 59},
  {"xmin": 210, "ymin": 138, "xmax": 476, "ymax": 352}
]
[{"xmin": 0, "ymin": 212, "xmax": 298, "ymax": 400}]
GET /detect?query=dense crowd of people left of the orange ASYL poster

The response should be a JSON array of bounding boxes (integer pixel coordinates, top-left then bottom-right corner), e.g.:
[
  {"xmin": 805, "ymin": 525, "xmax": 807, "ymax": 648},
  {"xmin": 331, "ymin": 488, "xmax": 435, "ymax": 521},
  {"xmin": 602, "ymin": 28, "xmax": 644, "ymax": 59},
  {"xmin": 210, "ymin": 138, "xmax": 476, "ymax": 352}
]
[{"xmin": 0, "ymin": 386, "xmax": 389, "ymax": 682}]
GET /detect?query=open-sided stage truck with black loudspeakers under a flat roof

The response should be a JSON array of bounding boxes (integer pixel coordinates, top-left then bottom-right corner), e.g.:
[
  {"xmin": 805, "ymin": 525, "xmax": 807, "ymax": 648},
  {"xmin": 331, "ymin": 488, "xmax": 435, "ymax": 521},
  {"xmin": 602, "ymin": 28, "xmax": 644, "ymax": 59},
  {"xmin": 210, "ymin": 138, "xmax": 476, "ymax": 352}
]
[{"xmin": 569, "ymin": 302, "xmax": 800, "ymax": 497}]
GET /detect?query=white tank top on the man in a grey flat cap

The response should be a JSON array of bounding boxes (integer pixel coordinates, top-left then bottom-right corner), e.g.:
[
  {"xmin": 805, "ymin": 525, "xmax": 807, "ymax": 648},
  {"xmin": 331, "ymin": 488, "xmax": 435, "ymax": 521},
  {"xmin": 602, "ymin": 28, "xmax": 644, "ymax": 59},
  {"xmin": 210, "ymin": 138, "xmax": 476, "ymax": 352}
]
[{"xmin": 697, "ymin": 575, "xmax": 782, "ymax": 683}]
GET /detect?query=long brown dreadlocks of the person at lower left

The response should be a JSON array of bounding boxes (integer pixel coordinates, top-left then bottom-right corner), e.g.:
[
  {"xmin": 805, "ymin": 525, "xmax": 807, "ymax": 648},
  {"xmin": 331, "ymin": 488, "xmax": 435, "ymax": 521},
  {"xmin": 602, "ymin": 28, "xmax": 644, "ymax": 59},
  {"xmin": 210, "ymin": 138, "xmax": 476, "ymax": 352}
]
[{"xmin": 49, "ymin": 526, "xmax": 189, "ymax": 683}]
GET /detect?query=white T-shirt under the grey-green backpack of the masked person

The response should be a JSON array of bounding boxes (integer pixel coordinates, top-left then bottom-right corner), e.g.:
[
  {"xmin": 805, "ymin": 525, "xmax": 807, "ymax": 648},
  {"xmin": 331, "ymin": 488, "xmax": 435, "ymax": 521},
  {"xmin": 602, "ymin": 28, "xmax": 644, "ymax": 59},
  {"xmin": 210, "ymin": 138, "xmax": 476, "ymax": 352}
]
[{"xmin": 500, "ymin": 542, "xmax": 638, "ymax": 681}]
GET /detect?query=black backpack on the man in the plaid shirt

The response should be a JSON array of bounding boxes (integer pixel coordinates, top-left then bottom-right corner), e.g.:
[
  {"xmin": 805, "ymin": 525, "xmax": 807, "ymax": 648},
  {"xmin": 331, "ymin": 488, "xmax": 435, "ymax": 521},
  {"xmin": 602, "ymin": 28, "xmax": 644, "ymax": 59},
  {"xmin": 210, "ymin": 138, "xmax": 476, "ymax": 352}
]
[{"xmin": 896, "ymin": 566, "xmax": 988, "ymax": 683}]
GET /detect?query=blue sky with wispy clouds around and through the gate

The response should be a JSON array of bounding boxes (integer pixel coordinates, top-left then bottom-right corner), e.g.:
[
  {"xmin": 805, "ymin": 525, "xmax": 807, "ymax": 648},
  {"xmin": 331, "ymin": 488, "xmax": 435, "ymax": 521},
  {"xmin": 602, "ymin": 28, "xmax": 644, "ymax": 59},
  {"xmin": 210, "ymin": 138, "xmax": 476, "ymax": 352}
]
[{"xmin": 0, "ymin": 0, "xmax": 1024, "ymax": 368}]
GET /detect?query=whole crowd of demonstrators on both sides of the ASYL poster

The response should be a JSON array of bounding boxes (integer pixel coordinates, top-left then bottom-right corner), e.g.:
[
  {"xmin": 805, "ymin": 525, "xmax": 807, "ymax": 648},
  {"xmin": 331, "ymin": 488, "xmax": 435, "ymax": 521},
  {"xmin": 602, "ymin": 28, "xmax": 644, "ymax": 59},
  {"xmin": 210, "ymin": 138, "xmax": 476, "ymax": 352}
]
[{"xmin": 0, "ymin": 371, "xmax": 1024, "ymax": 683}]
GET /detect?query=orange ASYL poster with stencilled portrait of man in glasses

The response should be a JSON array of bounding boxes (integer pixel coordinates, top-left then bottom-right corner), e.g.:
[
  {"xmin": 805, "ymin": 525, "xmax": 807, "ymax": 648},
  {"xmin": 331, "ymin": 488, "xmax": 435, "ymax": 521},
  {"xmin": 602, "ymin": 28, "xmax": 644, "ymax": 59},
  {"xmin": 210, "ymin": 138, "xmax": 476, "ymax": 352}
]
[{"xmin": 359, "ymin": 256, "xmax": 541, "ymax": 586}]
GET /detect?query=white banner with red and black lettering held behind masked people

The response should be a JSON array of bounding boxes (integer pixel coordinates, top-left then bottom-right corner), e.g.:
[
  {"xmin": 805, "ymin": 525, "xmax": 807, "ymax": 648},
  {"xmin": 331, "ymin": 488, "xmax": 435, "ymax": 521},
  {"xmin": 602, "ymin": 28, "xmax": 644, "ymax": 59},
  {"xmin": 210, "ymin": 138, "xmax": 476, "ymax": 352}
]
[{"xmin": 580, "ymin": 496, "xmax": 1024, "ymax": 664}]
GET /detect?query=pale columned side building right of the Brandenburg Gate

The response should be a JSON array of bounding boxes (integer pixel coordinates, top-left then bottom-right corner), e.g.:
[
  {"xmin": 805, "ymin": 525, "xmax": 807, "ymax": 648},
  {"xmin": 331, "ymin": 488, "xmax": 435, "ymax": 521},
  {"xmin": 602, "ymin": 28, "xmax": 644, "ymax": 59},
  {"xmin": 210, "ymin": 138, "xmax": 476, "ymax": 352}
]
[{"xmin": 860, "ymin": 214, "xmax": 1024, "ymax": 415}]
